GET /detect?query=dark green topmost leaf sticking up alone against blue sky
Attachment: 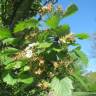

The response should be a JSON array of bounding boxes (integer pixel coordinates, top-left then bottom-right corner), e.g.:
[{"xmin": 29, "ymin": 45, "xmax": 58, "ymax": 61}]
[{"xmin": 63, "ymin": 4, "xmax": 78, "ymax": 17}]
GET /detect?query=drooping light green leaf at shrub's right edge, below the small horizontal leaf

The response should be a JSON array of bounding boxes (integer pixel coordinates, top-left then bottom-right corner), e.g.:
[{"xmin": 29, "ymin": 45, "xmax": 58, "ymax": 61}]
[{"xmin": 75, "ymin": 49, "xmax": 88, "ymax": 64}]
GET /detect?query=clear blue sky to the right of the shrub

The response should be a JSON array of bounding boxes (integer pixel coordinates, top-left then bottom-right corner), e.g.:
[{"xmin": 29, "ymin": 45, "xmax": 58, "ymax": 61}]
[{"xmin": 58, "ymin": 0, "xmax": 96, "ymax": 71}]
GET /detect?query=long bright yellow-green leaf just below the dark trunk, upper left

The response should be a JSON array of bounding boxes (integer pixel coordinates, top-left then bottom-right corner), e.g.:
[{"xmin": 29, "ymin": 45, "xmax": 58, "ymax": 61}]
[{"xmin": 14, "ymin": 18, "xmax": 38, "ymax": 33}]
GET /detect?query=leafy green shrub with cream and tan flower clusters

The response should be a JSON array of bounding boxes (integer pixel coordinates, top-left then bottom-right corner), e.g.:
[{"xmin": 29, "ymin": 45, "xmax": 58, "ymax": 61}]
[{"xmin": 0, "ymin": 0, "xmax": 94, "ymax": 96}]
